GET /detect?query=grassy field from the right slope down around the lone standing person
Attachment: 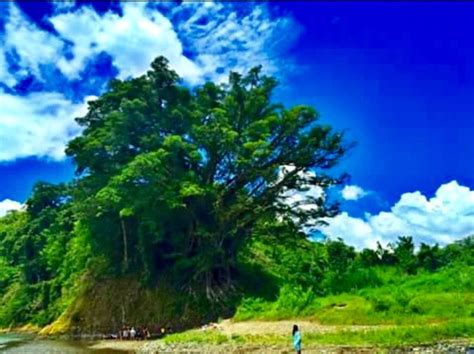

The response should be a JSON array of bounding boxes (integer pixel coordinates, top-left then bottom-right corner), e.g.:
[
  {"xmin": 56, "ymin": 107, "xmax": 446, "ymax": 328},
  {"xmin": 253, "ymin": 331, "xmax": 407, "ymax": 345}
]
[{"xmin": 157, "ymin": 265, "xmax": 474, "ymax": 347}]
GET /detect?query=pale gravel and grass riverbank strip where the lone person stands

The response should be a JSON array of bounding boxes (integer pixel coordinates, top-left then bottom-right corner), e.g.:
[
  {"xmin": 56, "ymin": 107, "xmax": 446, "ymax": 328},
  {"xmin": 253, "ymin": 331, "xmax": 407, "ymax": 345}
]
[{"xmin": 91, "ymin": 321, "xmax": 474, "ymax": 354}]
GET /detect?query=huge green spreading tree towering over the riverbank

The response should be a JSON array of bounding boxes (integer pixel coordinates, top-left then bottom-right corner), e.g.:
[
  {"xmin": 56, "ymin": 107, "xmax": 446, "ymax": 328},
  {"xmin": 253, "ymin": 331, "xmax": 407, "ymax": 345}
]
[{"xmin": 67, "ymin": 57, "xmax": 349, "ymax": 298}]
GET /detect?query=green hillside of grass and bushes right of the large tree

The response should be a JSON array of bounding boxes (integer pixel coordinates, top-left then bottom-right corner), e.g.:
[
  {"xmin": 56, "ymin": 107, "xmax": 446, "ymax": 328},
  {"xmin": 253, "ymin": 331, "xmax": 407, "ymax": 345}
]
[{"xmin": 234, "ymin": 237, "xmax": 474, "ymax": 325}]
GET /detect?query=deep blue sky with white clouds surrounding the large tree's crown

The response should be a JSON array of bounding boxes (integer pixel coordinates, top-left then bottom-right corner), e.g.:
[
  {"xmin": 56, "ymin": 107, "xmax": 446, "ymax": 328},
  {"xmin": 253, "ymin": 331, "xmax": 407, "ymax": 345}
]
[{"xmin": 0, "ymin": 2, "xmax": 474, "ymax": 247}]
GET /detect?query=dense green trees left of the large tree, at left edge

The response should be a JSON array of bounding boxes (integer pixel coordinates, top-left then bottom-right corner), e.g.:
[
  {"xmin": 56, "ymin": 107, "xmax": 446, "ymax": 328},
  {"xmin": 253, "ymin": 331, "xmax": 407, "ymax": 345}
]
[{"xmin": 0, "ymin": 183, "xmax": 90, "ymax": 327}]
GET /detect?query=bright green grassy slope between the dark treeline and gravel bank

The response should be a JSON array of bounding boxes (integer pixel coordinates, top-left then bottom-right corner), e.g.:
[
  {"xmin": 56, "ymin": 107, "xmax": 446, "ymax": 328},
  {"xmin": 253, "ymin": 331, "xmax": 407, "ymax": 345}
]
[{"xmin": 234, "ymin": 266, "xmax": 474, "ymax": 325}]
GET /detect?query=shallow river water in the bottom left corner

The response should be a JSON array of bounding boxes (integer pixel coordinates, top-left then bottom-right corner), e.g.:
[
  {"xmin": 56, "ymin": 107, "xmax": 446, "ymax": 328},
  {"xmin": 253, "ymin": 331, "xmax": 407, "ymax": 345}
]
[{"xmin": 0, "ymin": 334, "xmax": 124, "ymax": 354}]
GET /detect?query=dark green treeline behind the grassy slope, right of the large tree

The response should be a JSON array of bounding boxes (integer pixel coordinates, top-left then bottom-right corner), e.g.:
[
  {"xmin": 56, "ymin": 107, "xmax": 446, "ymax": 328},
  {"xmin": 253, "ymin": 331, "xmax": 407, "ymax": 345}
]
[{"xmin": 242, "ymin": 235, "xmax": 474, "ymax": 297}]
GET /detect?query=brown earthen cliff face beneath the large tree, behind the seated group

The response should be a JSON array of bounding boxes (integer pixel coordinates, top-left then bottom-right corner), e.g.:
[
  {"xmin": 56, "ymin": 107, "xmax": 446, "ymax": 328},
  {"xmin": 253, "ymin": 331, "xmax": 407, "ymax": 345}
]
[{"xmin": 41, "ymin": 278, "xmax": 215, "ymax": 335}]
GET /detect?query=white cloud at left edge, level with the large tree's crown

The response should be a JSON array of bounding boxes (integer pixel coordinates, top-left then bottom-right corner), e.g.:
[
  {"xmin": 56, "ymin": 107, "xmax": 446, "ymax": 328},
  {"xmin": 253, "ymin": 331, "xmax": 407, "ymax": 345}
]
[{"xmin": 0, "ymin": 91, "xmax": 89, "ymax": 161}]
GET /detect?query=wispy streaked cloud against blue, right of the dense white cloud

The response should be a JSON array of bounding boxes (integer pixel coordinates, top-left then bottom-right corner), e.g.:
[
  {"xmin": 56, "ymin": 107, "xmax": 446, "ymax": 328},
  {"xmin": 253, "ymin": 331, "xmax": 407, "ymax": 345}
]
[{"xmin": 175, "ymin": 2, "xmax": 300, "ymax": 81}]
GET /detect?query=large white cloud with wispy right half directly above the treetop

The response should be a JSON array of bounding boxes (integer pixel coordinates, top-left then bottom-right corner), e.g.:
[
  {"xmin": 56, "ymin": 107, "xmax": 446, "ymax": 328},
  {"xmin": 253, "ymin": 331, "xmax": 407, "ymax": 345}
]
[{"xmin": 50, "ymin": 2, "xmax": 299, "ymax": 84}]
